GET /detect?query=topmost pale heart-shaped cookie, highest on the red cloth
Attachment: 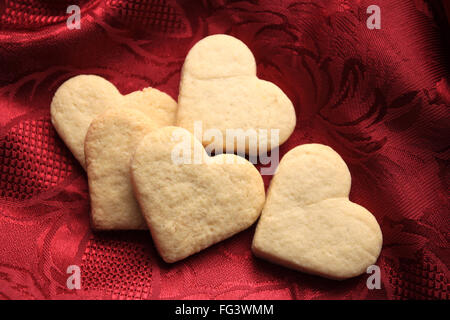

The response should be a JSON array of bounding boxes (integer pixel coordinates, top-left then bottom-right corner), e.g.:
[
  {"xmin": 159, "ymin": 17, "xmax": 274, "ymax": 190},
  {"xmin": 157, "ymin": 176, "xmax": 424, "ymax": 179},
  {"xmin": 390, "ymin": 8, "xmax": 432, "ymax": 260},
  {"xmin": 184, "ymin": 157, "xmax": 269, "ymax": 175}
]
[{"xmin": 177, "ymin": 34, "xmax": 296, "ymax": 153}]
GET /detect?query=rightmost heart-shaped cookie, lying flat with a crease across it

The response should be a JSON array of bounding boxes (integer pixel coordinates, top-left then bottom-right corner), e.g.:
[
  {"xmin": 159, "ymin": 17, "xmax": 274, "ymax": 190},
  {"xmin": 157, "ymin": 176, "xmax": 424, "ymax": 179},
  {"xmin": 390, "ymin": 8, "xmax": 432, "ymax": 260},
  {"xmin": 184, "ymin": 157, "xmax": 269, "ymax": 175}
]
[{"xmin": 252, "ymin": 144, "xmax": 382, "ymax": 279}]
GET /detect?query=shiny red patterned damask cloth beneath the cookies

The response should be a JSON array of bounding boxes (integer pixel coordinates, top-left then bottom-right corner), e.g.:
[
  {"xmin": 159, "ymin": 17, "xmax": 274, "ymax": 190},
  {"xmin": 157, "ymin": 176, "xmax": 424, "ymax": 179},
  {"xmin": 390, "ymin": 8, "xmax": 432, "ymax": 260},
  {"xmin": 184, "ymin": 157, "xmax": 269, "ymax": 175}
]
[{"xmin": 0, "ymin": 0, "xmax": 450, "ymax": 299}]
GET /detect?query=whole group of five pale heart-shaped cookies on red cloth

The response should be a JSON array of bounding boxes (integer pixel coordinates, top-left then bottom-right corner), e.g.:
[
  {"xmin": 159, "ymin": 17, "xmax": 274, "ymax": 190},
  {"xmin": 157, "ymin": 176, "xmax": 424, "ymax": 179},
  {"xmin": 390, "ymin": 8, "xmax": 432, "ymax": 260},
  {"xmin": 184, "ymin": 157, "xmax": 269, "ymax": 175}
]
[{"xmin": 51, "ymin": 35, "xmax": 382, "ymax": 279}]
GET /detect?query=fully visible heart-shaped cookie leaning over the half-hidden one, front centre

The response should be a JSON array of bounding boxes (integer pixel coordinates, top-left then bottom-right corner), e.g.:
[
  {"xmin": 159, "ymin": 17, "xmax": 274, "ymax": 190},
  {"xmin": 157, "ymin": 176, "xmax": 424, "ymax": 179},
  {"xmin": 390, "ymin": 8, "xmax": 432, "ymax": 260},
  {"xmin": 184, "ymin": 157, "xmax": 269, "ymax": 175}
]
[{"xmin": 131, "ymin": 127, "xmax": 265, "ymax": 262}]
